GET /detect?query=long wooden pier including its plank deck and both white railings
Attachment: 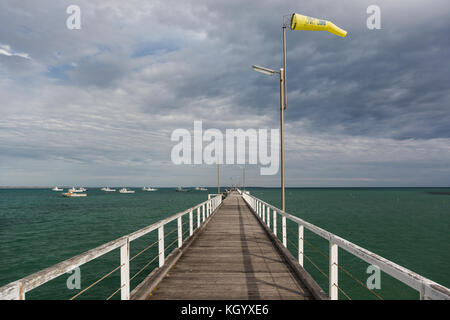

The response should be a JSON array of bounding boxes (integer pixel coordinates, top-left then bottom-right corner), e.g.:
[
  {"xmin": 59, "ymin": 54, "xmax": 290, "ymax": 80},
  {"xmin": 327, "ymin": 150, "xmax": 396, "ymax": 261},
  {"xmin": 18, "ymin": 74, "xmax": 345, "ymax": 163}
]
[{"xmin": 0, "ymin": 190, "xmax": 450, "ymax": 300}]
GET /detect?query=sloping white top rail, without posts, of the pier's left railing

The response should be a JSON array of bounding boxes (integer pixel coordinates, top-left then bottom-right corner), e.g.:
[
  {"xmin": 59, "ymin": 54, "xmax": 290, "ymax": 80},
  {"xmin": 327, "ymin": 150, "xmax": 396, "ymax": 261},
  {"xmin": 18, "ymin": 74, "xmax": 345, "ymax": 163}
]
[{"xmin": 0, "ymin": 195, "xmax": 221, "ymax": 300}]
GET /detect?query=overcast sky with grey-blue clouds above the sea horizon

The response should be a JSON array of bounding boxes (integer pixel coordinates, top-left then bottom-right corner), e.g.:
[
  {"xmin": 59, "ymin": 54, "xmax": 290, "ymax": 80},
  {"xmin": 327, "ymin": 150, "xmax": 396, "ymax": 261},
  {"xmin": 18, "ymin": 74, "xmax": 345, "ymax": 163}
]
[{"xmin": 0, "ymin": 0, "xmax": 450, "ymax": 187}]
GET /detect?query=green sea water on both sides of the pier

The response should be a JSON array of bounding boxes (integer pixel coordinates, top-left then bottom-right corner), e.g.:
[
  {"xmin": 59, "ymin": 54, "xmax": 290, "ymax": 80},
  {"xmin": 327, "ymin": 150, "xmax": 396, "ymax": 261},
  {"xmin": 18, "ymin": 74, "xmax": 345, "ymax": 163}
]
[{"xmin": 0, "ymin": 188, "xmax": 450, "ymax": 299}]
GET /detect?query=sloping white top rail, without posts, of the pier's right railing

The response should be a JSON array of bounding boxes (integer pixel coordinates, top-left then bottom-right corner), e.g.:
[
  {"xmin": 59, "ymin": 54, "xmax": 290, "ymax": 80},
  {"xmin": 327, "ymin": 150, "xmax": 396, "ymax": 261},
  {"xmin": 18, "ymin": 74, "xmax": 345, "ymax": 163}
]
[{"xmin": 238, "ymin": 190, "xmax": 450, "ymax": 300}]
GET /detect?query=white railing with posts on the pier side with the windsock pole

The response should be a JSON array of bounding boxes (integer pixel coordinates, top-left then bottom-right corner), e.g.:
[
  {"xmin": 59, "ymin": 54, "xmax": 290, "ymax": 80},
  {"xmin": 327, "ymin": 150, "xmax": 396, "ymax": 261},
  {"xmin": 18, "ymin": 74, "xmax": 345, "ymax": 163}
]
[{"xmin": 238, "ymin": 190, "xmax": 450, "ymax": 300}]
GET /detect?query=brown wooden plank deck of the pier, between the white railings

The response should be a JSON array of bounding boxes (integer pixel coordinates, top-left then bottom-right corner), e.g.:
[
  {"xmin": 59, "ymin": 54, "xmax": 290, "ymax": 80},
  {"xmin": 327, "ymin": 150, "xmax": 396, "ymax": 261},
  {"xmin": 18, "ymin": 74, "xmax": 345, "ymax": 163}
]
[{"xmin": 134, "ymin": 193, "xmax": 328, "ymax": 300}]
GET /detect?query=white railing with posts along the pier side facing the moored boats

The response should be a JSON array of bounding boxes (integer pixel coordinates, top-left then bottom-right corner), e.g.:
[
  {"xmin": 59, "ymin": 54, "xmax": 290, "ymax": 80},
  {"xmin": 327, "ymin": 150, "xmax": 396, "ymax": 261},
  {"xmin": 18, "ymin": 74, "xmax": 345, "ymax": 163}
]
[{"xmin": 0, "ymin": 195, "xmax": 222, "ymax": 300}]
